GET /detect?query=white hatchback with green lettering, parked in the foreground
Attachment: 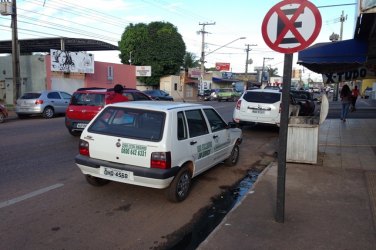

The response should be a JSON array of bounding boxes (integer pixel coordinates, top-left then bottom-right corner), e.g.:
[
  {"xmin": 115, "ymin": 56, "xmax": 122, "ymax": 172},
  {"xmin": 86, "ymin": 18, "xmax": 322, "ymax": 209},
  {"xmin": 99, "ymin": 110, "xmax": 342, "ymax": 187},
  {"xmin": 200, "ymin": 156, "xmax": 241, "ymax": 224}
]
[{"xmin": 75, "ymin": 101, "xmax": 242, "ymax": 202}]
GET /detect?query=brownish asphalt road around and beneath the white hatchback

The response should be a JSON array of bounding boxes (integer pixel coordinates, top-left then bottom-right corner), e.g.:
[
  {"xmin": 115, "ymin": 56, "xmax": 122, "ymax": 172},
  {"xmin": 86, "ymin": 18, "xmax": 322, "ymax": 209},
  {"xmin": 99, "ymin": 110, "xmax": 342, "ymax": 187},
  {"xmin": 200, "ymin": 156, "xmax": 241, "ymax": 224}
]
[{"xmin": 0, "ymin": 102, "xmax": 278, "ymax": 250}]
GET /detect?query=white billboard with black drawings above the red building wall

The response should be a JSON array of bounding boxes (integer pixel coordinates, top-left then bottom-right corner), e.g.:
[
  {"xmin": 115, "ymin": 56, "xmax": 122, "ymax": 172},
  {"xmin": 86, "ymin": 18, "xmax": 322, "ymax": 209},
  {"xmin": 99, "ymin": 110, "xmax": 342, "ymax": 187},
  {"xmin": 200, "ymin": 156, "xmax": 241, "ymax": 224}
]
[{"xmin": 50, "ymin": 49, "xmax": 94, "ymax": 74}]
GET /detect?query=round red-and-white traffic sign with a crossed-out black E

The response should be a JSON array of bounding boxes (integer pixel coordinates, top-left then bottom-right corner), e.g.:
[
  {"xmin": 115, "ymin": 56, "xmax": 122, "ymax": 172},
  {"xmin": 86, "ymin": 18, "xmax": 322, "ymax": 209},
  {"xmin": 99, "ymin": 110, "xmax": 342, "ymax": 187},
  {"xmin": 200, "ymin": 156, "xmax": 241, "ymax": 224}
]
[{"xmin": 261, "ymin": 0, "xmax": 322, "ymax": 54}]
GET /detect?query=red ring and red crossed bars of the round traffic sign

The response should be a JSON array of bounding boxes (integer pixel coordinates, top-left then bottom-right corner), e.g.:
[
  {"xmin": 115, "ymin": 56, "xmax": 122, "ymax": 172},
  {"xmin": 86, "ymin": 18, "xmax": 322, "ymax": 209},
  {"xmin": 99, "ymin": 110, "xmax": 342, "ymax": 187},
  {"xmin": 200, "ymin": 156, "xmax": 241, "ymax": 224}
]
[{"xmin": 261, "ymin": 0, "xmax": 322, "ymax": 54}]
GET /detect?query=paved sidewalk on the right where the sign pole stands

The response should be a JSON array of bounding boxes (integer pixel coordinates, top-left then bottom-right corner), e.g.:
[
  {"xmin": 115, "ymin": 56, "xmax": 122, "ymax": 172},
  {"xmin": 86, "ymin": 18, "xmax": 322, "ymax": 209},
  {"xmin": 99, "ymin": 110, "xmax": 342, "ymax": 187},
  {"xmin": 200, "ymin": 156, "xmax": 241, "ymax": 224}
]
[{"xmin": 198, "ymin": 119, "xmax": 376, "ymax": 249}]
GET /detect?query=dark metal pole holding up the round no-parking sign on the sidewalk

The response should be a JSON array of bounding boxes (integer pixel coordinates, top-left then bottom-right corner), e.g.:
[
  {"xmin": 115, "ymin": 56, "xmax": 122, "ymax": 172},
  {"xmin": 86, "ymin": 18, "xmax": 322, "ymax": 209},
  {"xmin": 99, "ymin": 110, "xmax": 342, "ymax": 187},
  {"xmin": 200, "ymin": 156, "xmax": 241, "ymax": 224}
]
[{"xmin": 275, "ymin": 54, "xmax": 293, "ymax": 223}]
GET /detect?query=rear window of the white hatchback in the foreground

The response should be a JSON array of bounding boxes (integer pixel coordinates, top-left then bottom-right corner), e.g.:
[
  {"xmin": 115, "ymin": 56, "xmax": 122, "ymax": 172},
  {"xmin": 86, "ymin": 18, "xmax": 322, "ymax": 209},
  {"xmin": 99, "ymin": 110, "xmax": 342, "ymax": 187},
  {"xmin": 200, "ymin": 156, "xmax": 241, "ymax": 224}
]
[{"xmin": 88, "ymin": 107, "xmax": 166, "ymax": 141}]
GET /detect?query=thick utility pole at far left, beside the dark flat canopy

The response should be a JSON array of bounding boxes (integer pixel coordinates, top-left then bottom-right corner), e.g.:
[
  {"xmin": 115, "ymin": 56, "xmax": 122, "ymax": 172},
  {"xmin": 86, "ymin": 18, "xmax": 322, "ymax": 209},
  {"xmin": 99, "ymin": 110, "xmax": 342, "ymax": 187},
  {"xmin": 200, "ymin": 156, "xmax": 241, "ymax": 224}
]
[{"xmin": 12, "ymin": 0, "xmax": 21, "ymax": 101}]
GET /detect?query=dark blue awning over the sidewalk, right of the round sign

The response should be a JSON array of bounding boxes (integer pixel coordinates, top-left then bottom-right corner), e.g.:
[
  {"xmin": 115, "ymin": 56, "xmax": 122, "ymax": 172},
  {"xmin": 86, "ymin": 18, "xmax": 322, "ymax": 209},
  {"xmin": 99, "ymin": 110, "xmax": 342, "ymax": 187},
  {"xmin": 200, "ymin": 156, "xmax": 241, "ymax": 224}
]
[{"xmin": 297, "ymin": 39, "xmax": 368, "ymax": 73}]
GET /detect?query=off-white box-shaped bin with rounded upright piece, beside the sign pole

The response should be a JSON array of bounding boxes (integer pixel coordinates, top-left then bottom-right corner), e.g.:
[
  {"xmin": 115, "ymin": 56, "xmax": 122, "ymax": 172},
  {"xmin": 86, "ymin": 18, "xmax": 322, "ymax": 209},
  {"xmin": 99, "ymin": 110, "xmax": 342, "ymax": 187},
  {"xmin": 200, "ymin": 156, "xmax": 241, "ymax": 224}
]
[{"xmin": 286, "ymin": 94, "xmax": 329, "ymax": 164}]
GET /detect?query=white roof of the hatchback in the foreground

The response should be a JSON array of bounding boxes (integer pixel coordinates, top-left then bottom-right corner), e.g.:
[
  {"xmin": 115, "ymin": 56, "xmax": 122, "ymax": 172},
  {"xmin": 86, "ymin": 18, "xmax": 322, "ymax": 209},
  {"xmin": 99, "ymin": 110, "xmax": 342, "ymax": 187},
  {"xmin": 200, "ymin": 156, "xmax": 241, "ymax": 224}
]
[{"xmin": 108, "ymin": 101, "xmax": 213, "ymax": 111}]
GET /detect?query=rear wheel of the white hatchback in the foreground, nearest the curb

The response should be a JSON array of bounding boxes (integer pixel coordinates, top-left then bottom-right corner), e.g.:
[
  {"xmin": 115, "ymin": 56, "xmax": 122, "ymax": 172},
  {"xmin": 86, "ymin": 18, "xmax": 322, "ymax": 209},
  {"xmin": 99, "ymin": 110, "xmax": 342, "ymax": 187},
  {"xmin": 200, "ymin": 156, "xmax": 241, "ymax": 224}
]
[{"xmin": 166, "ymin": 166, "xmax": 192, "ymax": 202}]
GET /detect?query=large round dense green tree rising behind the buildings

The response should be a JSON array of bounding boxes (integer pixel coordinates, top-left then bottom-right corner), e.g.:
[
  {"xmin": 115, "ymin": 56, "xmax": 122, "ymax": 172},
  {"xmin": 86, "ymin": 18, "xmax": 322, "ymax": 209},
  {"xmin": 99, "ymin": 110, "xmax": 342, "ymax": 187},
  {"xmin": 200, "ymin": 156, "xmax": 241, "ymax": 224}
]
[{"xmin": 119, "ymin": 22, "xmax": 186, "ymax": 85}]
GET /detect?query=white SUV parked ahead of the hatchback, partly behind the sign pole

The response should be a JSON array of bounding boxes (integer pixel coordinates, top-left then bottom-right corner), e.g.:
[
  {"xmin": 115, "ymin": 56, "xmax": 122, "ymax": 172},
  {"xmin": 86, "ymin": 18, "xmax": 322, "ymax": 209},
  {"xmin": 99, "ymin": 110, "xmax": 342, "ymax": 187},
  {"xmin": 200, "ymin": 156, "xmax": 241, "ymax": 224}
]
[{"xmin": 233, "ymin": 89, "xmax": 300, "ymax": 126}]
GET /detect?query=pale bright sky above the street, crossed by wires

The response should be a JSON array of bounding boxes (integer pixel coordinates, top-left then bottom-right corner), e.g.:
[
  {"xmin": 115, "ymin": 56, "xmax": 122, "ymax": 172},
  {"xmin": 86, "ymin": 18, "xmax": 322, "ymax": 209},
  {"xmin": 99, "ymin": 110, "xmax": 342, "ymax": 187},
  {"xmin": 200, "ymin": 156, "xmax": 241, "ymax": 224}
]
[{"xmin": 0, "ymin": 0, "xmax": 357, "ymax": 81}]
